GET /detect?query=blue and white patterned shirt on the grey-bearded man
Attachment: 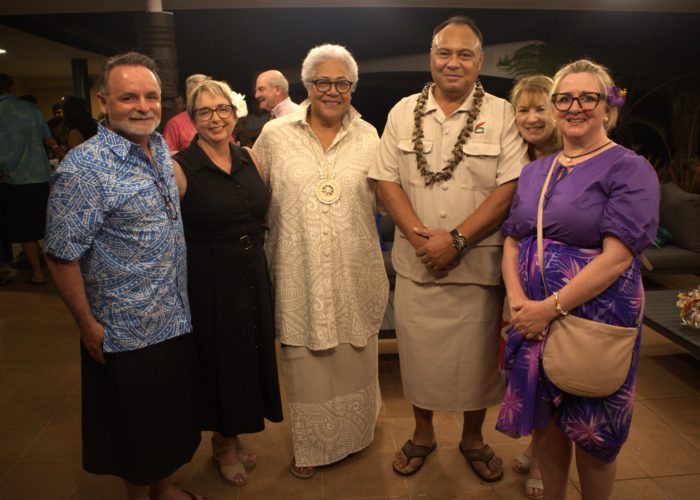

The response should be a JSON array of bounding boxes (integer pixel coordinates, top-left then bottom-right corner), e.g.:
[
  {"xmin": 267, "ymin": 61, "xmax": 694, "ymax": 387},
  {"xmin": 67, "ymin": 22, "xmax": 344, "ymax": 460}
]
[{"xmin": 46, "ymin": 122, "xmax": 192, "ymax": 352}]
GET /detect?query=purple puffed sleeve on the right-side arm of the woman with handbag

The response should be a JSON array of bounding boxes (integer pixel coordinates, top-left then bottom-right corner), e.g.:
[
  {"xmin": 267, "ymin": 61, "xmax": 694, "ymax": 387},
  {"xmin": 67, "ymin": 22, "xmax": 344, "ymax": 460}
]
[{"xmin": 600, "ymin": 152, "xmax": 660, "ymax": 255}]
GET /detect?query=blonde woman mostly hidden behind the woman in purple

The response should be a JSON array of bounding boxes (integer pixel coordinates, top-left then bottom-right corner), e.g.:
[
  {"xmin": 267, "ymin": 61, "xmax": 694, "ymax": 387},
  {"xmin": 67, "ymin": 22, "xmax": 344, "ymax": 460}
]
[{"xmin": 510, "ymin": 75, "xmax": 561, "ymax": 498}]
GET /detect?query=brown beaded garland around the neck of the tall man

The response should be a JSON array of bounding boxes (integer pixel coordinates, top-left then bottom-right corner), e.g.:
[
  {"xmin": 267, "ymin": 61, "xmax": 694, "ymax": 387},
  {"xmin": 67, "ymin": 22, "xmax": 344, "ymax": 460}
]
[{"xmin": 413, "ymin": 80, "xmax": 484, "ymax": 186}]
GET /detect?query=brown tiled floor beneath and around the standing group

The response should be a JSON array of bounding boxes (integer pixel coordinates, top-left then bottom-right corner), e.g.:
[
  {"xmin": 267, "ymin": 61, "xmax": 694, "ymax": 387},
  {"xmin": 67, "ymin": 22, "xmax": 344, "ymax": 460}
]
[{"xmin": 0, "ymin": 275, "xmax": 700, "ymax": 500}]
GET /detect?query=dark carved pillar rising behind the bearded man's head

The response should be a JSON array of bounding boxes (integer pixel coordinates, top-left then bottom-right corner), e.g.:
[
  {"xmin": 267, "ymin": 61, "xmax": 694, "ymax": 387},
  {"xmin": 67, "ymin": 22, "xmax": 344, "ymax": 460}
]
[{"xmin": 136, "ymin": 7, "xmax": 178, "ymax": 126}]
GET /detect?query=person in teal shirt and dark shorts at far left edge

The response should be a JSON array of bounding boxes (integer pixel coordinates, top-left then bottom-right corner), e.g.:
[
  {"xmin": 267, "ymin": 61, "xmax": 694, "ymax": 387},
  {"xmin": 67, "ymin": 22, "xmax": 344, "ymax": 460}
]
[{"xmin": 0, "ymin": 73, "xmax": 63, "ymax": 285}]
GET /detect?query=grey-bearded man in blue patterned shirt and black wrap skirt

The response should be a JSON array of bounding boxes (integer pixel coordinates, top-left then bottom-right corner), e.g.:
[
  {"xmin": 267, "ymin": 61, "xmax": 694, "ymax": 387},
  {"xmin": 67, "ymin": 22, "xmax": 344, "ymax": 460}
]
[{"xmin": 46, "ymin": 52, "xmax": 205, "ymax": 499}]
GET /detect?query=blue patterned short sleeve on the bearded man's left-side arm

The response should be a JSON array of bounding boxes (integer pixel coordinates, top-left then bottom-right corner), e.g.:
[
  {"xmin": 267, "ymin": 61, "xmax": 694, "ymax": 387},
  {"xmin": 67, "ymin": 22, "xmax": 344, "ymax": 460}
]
[{"xmin": 45, "ymin": 159, "xmax": 107, "ymax": 261}]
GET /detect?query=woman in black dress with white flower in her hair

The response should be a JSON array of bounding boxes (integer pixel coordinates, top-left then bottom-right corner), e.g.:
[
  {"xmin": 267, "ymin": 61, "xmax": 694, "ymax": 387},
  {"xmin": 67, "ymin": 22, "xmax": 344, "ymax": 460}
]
[{"xmin": 173, "ymin": 80, "xmax": 282, "ymax": 486}]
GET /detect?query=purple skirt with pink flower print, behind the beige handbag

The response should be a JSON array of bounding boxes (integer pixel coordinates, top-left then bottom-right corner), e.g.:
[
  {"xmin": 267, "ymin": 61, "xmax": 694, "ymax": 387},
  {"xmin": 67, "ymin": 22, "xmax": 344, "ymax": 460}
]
[{"xmin": 496, "ymin": 236, "xmax": 644, "ymax": 462}]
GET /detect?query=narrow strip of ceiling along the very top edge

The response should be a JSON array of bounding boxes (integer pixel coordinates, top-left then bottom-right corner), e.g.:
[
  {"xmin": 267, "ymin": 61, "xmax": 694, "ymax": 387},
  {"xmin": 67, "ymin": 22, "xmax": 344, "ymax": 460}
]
[{"xmin": 0, "ymin": 0, "xmax": 700, "ymax": 15}]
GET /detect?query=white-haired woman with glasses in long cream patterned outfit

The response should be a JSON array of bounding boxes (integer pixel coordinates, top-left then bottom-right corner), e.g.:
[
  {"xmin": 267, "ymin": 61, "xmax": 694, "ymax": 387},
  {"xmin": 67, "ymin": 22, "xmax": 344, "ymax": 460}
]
[{"xmin": 253, "ymin": 44, "xmax": 389, "ymax": 479}]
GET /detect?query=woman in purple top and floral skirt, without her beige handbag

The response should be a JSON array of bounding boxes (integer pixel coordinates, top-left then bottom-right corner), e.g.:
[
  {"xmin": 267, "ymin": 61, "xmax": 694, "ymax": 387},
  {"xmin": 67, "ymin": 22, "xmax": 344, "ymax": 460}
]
[{"xmin": 497, "ymin": 60, "xmax": 659, "ymax": 499}]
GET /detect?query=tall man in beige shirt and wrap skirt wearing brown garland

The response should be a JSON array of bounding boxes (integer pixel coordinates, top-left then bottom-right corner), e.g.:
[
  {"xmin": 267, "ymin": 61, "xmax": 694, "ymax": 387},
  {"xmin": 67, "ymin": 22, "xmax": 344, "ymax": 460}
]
[{"xmin": 370, "ymin": 16, "xmax": 527, "ymax": 482}]
